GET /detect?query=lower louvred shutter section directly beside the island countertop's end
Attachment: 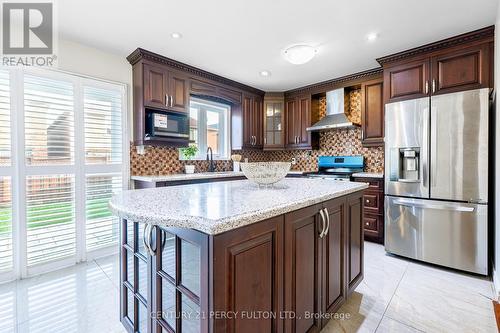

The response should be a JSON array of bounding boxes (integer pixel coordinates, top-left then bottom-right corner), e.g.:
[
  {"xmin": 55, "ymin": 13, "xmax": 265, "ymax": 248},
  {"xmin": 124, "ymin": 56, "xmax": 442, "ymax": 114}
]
[{"xmin": 85, "ymin": 174, "xmax": 123, "ymax": 250}]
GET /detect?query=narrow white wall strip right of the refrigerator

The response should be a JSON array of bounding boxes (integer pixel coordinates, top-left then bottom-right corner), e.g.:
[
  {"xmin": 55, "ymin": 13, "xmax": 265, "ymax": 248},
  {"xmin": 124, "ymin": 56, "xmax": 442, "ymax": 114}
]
[{"xmin": 493, "ymin": 0, "xmax": 500, "ymax": 296}]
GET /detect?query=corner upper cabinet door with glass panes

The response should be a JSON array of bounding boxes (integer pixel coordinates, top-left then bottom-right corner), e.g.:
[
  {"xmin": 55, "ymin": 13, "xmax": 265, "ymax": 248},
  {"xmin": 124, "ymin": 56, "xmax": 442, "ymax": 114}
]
[{"xmin": 264, "ymin": 95, "xmax": 285, "ymax": 150}]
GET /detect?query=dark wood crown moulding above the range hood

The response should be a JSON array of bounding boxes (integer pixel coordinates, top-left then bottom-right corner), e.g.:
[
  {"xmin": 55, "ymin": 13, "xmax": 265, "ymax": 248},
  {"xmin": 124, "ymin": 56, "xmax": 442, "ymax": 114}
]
[{"xmin": 285, "ymin": 67, "xmax": 382, "ymax": 98}]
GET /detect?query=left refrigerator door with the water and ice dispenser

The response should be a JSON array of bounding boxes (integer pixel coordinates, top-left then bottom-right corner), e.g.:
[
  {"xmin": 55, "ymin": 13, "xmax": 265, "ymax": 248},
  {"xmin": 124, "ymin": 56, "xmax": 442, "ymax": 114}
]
[{"xmin": 385, "ymin": 97, "xmax": 430, "ymax": 198}]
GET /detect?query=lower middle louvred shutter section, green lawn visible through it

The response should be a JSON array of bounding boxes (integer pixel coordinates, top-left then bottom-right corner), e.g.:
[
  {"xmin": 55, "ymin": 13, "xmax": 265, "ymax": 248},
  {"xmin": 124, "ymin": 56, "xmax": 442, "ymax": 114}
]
[{"xmin": 26, "ymin": 175, "xmax": 76, "ymax": 266}]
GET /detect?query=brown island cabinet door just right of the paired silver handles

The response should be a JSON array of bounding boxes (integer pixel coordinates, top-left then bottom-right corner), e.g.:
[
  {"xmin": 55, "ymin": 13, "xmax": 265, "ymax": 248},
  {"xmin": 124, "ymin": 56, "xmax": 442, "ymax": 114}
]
[{"xmin": 321, "ymin": 198, "xmax": 347, "ymax": 326}]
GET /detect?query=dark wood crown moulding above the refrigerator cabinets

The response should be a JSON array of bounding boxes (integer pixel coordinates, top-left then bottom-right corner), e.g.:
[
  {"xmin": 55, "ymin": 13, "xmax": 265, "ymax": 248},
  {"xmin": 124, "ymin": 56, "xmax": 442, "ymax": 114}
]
[{"xmin": 377, "ymin": 25, "xmax": 495, "ymax": 66}]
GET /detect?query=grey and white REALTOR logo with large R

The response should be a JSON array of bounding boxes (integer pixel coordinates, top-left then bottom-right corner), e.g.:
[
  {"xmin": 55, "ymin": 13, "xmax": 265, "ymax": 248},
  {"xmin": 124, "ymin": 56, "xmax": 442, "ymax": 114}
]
[{"xmin": 2, "ymin": 0, "xmax": 57, "ymax": 66}]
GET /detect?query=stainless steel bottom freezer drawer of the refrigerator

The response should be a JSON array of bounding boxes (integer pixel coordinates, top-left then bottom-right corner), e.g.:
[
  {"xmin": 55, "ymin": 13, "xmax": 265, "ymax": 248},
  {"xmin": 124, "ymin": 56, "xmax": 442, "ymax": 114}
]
[{"xmin": 385, "ymin": 196, "xmax": 488, "ymax": 275}]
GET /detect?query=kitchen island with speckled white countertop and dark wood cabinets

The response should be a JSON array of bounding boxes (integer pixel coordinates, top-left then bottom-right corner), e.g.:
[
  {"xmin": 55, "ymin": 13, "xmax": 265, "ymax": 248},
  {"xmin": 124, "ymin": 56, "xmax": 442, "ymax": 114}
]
[{"xmin": 110, "ymin": 178, "xmax": 368, "ymax": 332}]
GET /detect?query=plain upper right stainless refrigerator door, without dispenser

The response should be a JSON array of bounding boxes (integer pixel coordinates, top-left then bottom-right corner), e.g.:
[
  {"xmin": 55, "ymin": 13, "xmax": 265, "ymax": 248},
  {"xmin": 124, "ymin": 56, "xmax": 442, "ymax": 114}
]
[{"xmin": 430, "ymin": 88, "xmax": 489, "ymax": 203}]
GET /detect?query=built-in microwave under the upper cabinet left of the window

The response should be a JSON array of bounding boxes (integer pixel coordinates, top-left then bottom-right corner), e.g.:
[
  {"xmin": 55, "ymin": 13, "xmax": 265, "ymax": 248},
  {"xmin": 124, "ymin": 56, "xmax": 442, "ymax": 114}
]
[{"xmin": 146, "ymin": 112, "xmax": 189, "ymax": 139}]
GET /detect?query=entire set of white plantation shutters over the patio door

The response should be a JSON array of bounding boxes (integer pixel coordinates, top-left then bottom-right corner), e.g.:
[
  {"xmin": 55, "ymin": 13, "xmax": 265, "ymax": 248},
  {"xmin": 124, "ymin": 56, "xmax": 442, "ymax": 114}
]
[{"xmin": 0, "ymin": 68, "xmax": 128, "ymax": 282}]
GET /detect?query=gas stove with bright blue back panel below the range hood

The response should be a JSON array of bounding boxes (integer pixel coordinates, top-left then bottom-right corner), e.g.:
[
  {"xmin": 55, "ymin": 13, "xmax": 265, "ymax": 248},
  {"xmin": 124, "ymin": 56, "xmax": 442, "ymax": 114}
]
[{"xmin": 306, "ymin": 155, "xmax": 364, "ymax": 181}]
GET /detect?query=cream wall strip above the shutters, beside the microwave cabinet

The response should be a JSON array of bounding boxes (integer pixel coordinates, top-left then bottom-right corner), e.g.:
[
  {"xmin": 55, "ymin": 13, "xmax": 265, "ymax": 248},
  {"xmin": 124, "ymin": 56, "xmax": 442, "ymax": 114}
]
[{"xmin": 57, "ymin": 40, "xmax": 132, "ymax": 138}]
